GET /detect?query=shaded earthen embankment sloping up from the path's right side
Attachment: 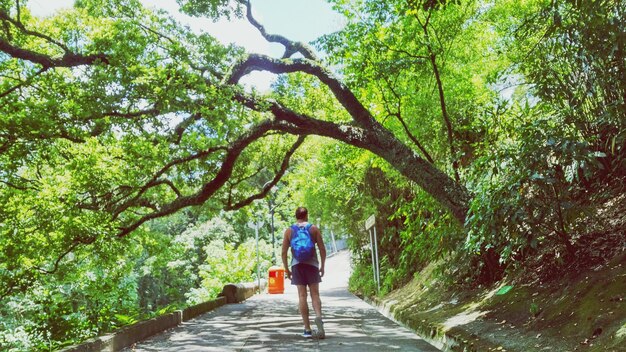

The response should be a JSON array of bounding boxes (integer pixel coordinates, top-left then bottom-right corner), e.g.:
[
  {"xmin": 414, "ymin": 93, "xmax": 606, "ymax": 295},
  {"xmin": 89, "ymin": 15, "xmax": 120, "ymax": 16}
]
[{"xmin": 370, "ymin": 254, "xmax": 626, "ymax": 352}]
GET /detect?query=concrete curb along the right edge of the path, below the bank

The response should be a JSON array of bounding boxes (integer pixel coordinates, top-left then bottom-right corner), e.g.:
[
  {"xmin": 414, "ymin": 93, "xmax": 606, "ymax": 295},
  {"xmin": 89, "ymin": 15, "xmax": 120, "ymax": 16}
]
[{"xmin": 364, "ymin": 298, "xmax": 498, "ymax": 352}]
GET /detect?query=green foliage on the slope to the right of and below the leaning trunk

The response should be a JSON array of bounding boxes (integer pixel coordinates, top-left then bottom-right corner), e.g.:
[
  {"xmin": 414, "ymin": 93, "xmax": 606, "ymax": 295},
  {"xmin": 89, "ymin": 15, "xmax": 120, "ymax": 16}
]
[{"xmin": 319, "ymin": 1, "xmax": 626, "ymax": 294}]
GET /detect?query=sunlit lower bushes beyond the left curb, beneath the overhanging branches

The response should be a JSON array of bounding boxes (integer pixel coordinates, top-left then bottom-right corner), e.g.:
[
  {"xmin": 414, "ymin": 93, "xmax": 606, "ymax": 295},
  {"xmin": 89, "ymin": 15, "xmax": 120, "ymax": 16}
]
[{"xmin": 0, "ymin": 204, "xmax": 272, "ymax": 351}]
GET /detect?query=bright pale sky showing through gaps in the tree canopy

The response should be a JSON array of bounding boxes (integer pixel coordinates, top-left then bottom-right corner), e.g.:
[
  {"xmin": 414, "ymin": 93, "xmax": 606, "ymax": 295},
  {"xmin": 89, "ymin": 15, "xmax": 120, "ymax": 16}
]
[{"xmin": 28, "ymin": 0, "xmax": 343, "ymax": 90}]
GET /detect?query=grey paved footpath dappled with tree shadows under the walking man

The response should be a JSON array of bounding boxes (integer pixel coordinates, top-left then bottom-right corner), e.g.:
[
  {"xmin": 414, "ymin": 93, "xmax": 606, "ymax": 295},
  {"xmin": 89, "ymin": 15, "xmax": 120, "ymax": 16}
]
[{"xmin": 125, "ymin": 251, "xmax": 439, "ymax": 352}]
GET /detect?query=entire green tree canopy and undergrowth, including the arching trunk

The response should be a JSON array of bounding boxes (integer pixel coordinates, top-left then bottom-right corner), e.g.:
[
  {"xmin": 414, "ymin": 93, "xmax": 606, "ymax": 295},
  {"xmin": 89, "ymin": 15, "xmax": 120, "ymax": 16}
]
[{"xmin": 0, "ymin": 0, "xmax": 626, "ymax": 350}]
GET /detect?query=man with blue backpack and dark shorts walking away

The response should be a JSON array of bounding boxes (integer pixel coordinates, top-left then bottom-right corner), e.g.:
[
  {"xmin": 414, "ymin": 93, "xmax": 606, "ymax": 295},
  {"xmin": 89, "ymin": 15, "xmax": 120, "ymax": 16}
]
[{"xmin": 282, "ymin": 207, "xmax": 326, "ymax": 339}]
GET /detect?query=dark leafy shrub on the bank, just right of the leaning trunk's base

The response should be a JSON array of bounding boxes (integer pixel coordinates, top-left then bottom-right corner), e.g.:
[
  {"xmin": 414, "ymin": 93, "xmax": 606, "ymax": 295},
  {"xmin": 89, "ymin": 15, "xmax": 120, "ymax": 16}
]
[{"xmin": 465, "ymin": 119, "xmax": 603, "ymax": 281}]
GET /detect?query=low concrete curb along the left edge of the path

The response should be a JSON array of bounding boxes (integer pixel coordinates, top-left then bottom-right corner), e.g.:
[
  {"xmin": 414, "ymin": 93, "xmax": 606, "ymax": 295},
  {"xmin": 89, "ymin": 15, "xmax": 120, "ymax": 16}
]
[{"xmin": 59, "ymin": 280, "xmax": 267, "ymax": 352}]
